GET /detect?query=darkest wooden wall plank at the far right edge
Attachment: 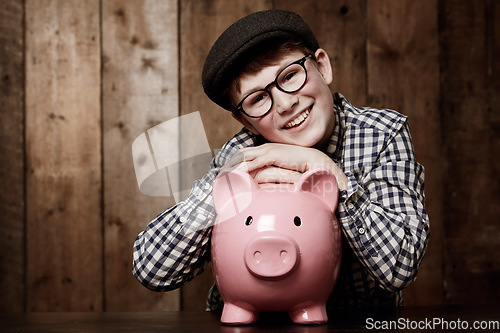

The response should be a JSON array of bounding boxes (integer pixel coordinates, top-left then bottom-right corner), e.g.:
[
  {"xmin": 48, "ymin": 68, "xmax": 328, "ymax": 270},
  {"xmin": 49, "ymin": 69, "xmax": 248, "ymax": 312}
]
[{"xmin": 439, "ymin": 0, "xmax": 500, "ymax": 304}]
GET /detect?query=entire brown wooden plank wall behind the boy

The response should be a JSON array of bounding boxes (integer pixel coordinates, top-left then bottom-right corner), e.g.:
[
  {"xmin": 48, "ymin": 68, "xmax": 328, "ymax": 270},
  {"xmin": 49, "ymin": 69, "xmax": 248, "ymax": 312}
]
[{"xmin": 0, "ymin": 0, "xmax": 500, "ymax": 311}]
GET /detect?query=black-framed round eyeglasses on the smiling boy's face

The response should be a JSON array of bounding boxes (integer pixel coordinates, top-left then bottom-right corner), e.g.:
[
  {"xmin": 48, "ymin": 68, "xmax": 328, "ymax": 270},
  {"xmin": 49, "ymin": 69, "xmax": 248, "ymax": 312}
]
[{"xmin": 236, "ymin": 55, "xmax": 311, "ymax": 118}]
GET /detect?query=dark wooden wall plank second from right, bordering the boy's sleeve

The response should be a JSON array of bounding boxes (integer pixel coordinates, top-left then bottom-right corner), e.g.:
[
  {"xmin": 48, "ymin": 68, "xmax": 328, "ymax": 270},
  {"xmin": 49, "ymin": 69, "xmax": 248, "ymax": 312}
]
[{"xmin": 367, "ymin": 0, "xmax": 444, "ymax": 305}]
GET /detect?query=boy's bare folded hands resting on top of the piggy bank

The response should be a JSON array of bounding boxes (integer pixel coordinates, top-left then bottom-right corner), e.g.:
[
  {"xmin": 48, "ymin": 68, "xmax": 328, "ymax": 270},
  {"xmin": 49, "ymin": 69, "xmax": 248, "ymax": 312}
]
[{"xmin": 224, "ymin": 143, "xmax": 347, "ymax": 190}]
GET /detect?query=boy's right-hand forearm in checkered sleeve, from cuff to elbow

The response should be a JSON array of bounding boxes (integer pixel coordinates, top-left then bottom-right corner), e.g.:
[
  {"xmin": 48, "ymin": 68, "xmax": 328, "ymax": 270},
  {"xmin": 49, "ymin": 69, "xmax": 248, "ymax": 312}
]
[{"xmin": 338, "ymin": 165, "xmax": 429, "ymax": 291}]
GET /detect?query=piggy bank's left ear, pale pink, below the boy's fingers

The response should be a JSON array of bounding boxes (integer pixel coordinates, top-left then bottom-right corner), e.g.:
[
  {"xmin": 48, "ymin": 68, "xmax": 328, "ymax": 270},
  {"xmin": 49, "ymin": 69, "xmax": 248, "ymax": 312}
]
[{"xmin": 213, "ymin": 169, "xmax": 259, "ymax": 216}]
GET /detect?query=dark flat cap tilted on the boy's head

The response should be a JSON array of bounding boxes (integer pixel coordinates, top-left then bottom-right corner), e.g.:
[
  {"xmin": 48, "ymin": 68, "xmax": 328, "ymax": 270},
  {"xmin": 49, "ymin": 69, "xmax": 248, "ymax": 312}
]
[{"xmin": 202, "ymin": 9, "xmax": 319, "ymax": 110}]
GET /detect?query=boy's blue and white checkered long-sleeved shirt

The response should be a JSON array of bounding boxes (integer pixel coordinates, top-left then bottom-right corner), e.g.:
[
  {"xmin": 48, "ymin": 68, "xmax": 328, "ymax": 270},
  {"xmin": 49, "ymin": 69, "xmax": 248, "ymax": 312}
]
[{"xmin": 133, "ymin": 93, "xmax": 429, "ymax": 310}]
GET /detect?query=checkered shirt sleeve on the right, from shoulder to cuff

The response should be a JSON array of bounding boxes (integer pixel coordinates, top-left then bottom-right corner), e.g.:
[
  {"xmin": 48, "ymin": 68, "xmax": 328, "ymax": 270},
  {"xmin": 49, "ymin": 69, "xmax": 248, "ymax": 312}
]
[{"xmin": 338, "ymin": 122, "xmax": 429, "ymax": 291}]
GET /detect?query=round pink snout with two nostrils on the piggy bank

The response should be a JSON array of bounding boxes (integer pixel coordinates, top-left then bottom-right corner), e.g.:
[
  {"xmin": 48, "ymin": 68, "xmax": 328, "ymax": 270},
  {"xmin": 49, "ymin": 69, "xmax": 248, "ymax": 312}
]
[{"xmin": 244, "ymin": 235, "xmax": 299, "ymax": 278}]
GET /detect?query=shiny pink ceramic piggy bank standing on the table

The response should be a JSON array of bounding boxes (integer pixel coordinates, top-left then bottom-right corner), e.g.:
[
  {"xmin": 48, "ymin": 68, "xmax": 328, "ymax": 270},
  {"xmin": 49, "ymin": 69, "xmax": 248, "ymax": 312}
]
[{"xmin": 211, "ymin": 169, "xmax": 341, "ymax": 325}]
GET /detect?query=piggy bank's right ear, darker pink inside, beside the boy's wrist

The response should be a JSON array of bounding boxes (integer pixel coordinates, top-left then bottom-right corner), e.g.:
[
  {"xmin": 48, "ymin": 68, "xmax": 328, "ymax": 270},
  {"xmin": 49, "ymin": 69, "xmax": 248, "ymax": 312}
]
[{"xmin": 295, "ymin": 168, "xmax": 339, "ymax": 212}]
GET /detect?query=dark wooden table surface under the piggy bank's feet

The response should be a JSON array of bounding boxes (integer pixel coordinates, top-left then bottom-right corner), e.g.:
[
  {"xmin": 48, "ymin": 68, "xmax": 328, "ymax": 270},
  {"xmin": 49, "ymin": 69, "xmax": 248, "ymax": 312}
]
[{"xmin": 0, "ymin": 305, "xmax": 500, "ymax": 333}]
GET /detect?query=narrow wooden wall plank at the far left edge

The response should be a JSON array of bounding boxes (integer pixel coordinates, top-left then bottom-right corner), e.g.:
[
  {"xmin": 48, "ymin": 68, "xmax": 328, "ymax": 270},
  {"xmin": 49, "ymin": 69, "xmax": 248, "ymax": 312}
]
[{"xmin": 0, "ymin": 0, "xmax": 25, "ymax": 312}]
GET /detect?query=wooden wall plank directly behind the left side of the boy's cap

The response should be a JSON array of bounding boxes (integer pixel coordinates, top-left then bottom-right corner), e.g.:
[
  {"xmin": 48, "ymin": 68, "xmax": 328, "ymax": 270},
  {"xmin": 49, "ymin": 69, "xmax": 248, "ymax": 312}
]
[{"xmin": 180, "ymin": 0, "xmax": 271, "ymax": 310}]
